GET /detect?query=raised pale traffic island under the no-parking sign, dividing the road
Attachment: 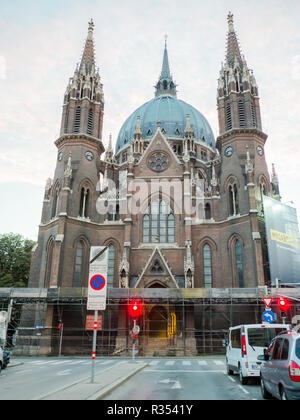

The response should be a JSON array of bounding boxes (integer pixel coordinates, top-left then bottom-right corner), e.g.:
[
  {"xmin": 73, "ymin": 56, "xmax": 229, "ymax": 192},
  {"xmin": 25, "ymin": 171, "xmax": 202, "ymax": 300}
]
[{"xmin": 39, "ymin": 361, "xmax": 148, "ymax": 400}]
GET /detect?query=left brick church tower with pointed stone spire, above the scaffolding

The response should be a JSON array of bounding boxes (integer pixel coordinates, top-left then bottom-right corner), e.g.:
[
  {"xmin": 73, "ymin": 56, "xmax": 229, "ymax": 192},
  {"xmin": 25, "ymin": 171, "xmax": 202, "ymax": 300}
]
[{"xmin": 30, "ymin": 20, "xmax": 104, "ymax": 288}]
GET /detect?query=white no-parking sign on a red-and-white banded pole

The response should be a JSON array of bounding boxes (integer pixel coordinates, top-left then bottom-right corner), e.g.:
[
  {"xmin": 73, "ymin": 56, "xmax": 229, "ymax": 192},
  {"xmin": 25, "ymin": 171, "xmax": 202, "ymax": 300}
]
[{"xmin": 87, "ymin": 246, "xmax": 108, "ymax": 383}]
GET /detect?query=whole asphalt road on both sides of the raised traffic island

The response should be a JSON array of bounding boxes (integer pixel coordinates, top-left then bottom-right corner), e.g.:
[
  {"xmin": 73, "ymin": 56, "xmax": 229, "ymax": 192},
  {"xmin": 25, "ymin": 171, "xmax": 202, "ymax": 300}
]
[{"xmin": 0, "ymin": 357, "xmax": 262, "ymax": 401}]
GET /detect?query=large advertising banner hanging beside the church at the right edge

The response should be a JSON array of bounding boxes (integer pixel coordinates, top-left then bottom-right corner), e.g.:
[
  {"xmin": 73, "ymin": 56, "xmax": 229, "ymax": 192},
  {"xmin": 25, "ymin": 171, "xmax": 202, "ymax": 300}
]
[{"xmin": 263, "ymin": 196, "xmax": 300, "ymax": 286}]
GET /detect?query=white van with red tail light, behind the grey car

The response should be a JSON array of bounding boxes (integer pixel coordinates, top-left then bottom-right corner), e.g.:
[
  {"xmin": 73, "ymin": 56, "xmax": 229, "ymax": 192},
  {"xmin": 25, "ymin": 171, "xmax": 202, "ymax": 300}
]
[{"xmin": 225, "ymin": 324, "xmax": 291, "ymax": 385}]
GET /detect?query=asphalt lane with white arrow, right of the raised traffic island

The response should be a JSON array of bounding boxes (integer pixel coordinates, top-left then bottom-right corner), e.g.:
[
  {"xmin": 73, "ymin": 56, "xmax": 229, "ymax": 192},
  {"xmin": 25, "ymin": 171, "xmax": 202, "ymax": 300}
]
[{"xmin": 104, "ymin": 358, "xmax": 262, "ymax": 401}]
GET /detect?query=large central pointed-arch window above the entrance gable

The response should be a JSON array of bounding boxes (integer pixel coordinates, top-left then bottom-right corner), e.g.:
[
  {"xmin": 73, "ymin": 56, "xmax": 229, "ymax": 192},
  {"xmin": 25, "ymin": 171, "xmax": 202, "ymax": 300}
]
[{"xmin": 143, "ymin": 199, "xmax": 175, "ymax": 243}]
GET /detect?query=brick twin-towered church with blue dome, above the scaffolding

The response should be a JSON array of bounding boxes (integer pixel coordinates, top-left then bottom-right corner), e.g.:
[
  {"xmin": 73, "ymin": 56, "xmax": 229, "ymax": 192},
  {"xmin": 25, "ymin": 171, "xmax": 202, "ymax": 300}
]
[{"xmin": 29, "ymin": 13, "xmax": 279, "ymax": 354}]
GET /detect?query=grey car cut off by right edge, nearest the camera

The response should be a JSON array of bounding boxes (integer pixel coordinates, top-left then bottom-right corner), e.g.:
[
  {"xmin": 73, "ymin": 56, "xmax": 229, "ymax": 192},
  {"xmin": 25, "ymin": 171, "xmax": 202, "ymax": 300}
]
[{"xmin": 258, "ymin": 330, "xmax": 300, "ymax": 400}]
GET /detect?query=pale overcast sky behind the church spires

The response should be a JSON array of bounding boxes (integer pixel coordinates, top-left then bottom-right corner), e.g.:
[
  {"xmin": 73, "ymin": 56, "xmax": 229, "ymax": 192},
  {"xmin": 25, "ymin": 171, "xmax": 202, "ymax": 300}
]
[{"xmin": 0, "ymin": 0, "xmax": 300, "ymax": 239}]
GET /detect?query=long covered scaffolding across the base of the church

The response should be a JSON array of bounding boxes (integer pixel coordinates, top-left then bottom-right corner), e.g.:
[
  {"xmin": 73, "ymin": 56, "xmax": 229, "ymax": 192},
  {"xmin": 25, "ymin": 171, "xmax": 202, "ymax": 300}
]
[{"xmin": 0, "ymin": 287, "xmax": 300, "ymax": 356}]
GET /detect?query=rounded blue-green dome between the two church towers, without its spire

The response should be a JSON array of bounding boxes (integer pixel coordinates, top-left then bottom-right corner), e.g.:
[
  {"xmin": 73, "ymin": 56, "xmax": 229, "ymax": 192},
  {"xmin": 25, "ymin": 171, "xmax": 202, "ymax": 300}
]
[{"xmin": 116, "ymin": 95, "xmax": 215, "ymax": 154}]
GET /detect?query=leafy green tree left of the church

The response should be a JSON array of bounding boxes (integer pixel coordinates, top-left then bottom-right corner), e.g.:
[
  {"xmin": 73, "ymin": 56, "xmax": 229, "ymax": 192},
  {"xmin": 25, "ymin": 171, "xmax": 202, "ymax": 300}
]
[{"xmin": 0, "ymin": 233, "xmax": 35, "ymax": 287}]
